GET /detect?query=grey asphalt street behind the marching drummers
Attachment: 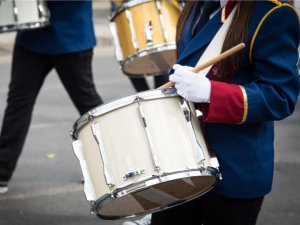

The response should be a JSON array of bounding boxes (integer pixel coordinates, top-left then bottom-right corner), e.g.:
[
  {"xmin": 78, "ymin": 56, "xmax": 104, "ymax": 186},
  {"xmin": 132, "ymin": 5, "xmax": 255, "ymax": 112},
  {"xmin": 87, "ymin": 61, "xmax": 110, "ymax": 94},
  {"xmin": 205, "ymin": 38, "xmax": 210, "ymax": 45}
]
[{"xmin": 0, "ymin": 2, "xmax": 300, "ymax": 225}]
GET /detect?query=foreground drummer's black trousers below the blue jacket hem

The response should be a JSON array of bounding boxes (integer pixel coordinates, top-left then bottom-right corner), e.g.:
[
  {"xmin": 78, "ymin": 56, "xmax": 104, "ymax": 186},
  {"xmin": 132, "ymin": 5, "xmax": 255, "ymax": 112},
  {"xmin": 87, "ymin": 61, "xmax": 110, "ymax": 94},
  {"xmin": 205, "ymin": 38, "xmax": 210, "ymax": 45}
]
[{"xmin": 151, "ymin": 192, "xmax": 264, "ymax": 225}]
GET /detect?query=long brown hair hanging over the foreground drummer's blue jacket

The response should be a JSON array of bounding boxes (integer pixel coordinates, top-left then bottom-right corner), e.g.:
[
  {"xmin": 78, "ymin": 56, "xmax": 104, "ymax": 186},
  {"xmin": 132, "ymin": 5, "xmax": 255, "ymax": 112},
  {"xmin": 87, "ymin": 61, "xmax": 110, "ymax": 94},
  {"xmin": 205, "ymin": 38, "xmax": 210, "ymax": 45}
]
[{"xmin": 176, "ymin": 1, "xmax": 255, "ymax": 81}]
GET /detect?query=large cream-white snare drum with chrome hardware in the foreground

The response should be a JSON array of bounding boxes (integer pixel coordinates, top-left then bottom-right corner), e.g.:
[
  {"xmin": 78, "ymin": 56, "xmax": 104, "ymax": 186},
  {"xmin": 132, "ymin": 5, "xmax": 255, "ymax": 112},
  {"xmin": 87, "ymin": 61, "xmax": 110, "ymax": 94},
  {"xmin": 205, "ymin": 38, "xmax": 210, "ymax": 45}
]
[{"xmin": 71, "ymin": 89, "xmax": 220, "ymax": 219}]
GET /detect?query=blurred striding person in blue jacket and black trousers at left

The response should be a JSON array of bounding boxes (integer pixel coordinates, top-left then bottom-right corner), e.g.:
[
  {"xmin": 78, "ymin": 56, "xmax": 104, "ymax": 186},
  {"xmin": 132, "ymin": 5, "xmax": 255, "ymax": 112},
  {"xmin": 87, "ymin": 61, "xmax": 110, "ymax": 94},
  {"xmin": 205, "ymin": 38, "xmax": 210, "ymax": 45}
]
[{"xmin": 0, "ymin": 0, "xmax": 103, "ymax": 194}]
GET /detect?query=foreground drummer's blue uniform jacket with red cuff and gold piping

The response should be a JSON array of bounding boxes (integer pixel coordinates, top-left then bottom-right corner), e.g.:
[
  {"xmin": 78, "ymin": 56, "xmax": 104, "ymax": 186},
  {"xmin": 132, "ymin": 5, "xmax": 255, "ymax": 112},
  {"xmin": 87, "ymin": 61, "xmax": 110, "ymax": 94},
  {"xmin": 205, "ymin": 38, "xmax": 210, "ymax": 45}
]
[{"xmin": 177, "ymin": 0, "xmax": 300, "ymax": 198}]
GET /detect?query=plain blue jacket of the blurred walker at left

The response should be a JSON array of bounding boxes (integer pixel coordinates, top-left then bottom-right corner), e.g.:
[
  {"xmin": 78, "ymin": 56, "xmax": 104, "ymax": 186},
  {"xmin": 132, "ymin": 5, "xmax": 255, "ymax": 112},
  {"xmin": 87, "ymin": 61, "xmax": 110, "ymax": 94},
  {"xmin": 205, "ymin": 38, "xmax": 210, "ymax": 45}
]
[{"xmin": 16, "ymin": 0, "xmax": 96, "ymax": 55}]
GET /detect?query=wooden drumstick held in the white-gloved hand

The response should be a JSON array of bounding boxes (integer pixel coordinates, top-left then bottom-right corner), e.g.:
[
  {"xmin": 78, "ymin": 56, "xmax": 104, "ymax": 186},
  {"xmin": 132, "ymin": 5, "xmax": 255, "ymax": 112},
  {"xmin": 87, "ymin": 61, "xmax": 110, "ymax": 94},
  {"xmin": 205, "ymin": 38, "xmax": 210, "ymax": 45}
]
[{"xmin": 157, "ymin": 43, "xmax": 245, "ymax": 89}]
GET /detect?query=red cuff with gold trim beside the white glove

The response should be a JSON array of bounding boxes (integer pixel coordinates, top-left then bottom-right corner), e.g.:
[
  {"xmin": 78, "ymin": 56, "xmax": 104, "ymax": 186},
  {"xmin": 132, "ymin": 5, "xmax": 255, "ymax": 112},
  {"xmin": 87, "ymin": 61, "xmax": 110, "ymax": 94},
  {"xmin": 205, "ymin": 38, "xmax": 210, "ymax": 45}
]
[{"xmin": 202, "ymin": 81, "xmax": 248, "ymax": 123}]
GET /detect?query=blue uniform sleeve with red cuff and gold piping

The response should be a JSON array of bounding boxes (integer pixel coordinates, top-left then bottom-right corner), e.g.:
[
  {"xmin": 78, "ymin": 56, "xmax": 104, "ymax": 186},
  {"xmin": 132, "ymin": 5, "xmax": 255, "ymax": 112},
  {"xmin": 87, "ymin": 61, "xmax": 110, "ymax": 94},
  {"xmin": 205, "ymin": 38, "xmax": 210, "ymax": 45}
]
[{"xmin": 202, "ymin": 4, "xmax": 300, "ymax": 123}]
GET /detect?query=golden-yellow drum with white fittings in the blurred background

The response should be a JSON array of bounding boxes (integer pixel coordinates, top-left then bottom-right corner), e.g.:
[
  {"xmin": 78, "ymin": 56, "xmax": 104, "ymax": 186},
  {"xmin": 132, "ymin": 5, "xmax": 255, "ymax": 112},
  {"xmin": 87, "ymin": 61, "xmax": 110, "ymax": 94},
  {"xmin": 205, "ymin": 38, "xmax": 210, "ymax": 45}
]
[{"xmin": 110, "ymin": 0, "xmax": 181, "ymax": 77}]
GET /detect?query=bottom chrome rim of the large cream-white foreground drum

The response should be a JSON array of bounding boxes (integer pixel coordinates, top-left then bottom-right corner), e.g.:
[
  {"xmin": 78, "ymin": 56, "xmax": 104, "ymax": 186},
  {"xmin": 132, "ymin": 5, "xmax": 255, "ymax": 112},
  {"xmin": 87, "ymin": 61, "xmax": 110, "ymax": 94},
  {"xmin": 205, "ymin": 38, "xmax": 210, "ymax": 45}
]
[{"xmin": 91, "ymin": 167, "xmax": 219, "ymax": 220}]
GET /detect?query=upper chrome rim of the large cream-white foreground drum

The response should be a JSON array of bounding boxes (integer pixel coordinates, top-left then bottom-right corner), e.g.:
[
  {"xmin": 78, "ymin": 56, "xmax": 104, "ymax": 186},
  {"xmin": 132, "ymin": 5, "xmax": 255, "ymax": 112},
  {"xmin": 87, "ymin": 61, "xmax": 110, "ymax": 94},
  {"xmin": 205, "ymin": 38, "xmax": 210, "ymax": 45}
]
[{"xmin": 70, "ymin": 88, "xmax": 180, "ymax": 140}]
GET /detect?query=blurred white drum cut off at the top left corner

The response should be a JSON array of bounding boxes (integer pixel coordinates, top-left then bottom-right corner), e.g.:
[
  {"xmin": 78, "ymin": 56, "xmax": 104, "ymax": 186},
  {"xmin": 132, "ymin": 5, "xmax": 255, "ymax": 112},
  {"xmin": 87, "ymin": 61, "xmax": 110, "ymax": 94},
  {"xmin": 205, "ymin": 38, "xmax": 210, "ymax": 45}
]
[{"xmin": 0, "ymin": 0, "xmax": 50, "ymax": 33}]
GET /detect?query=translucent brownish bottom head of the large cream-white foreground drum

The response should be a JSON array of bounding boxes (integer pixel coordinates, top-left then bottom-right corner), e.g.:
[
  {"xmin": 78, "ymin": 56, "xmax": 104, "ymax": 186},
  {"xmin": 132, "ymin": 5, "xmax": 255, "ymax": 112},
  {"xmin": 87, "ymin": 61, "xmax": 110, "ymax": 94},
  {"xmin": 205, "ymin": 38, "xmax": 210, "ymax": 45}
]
[{"xmin": 95, "ymin": 173, "xmax": 217, "ymax": 219}]
